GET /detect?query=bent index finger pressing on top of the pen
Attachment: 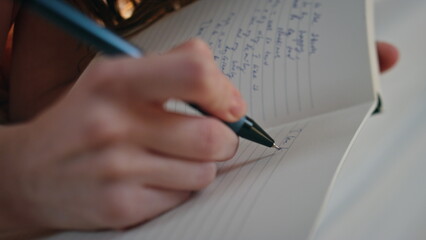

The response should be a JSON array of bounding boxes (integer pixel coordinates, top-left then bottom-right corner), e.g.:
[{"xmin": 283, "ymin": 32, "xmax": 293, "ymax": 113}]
[{"xmin": 88, "ymin": 39, "xmax": 246, "ymax": 122}]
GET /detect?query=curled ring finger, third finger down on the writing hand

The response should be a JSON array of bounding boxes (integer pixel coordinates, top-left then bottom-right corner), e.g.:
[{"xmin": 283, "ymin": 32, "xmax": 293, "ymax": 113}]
[{"xmin": 89, "ymin": 145, "xmax": 216, "ymax": 191}]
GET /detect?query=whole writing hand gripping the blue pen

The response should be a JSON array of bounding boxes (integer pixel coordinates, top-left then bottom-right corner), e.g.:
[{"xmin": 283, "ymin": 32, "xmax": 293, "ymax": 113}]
[{"xmin": 0, "ymin": 40, "xmax": 245, "ymax": 232}]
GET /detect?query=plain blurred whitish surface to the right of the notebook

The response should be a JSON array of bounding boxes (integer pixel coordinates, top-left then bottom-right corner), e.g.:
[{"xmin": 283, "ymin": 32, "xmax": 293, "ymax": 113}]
[{"xmin": 315, "ymin": 0, "xmax": 426, "ymax": 240}]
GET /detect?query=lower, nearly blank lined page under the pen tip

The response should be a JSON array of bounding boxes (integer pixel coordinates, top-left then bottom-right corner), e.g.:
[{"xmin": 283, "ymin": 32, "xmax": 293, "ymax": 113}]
[{"xmin": 45, "ymin": 104, "xmax": 373, "ymax": 240}]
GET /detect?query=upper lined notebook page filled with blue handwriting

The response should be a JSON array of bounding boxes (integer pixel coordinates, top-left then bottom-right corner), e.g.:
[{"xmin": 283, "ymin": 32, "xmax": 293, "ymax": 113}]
[{"xmin": 132, "ymin": 0, "xmax": 375, "ymax": 127}]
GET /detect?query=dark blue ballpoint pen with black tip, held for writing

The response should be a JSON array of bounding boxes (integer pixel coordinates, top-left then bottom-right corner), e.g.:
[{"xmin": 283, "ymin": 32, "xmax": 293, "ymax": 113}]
[{"xmin": 21, "ymin": 0, "xmax": 281, "ymax": 150}]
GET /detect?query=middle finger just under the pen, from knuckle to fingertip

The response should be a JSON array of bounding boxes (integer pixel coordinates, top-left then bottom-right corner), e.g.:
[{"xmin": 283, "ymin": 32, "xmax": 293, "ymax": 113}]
[{"xmin": 68, "ymin": 102, "xmax": 238, "ymax": 162}]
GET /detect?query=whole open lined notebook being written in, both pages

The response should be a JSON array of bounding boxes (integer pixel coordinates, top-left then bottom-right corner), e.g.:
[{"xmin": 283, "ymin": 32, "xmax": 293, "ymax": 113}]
[{"xmin": 46, "ymin": 0, "xmax": 378, "ymax": 240}]
